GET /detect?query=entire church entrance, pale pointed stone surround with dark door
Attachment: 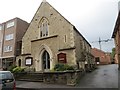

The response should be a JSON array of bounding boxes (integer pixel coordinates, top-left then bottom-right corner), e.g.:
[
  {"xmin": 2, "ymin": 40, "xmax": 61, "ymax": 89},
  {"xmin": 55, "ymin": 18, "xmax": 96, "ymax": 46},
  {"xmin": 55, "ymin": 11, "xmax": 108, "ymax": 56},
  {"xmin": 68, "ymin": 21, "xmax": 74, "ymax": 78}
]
[{"xmin": 35, "ymin": 45, "xmax": 54, "ymax": 72}]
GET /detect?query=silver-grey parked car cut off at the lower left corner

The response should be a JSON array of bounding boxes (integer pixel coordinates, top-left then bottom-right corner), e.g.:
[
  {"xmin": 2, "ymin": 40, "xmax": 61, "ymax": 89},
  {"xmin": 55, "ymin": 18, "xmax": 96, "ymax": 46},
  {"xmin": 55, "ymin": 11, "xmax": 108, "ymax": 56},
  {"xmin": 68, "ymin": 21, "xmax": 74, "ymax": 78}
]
[{"xmin": 0, "ymin": 71, "xmax": 16, "ymax": 90}]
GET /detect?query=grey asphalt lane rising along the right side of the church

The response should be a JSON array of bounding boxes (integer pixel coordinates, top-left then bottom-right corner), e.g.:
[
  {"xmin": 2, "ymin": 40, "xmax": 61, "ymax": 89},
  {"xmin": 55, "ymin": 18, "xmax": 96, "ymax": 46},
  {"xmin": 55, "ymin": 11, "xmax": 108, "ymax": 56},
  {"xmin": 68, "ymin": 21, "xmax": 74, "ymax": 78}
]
[{"xmin": 77, "ymin": 64, "xmax": 118, "ymax": 88}]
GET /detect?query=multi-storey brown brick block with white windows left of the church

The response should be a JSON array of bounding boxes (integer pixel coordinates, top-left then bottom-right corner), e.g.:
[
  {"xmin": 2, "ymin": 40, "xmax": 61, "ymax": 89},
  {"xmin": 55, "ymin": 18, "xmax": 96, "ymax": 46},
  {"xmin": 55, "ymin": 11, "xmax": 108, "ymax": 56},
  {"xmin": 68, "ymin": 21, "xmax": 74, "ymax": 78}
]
[{"xmin": 0, "ymin": 17, "xmax": 29, "ymax": 68}]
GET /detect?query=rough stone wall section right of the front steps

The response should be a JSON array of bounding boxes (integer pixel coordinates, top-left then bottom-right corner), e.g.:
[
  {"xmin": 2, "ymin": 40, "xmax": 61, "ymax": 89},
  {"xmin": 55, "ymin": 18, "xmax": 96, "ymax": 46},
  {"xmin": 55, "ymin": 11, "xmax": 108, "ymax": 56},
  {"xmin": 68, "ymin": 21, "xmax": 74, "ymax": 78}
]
[{"xmin": 43, "ymin": 70, "xmax": 84, "ymax": 85}]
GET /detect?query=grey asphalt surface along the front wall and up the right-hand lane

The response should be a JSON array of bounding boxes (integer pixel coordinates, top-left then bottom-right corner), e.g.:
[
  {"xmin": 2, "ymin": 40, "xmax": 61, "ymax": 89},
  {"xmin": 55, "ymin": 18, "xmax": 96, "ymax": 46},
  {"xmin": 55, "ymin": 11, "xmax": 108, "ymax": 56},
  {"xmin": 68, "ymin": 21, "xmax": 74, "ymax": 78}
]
[{"xmin": 16, "ymin": 64, "xmax": 118, "ymax": 89}]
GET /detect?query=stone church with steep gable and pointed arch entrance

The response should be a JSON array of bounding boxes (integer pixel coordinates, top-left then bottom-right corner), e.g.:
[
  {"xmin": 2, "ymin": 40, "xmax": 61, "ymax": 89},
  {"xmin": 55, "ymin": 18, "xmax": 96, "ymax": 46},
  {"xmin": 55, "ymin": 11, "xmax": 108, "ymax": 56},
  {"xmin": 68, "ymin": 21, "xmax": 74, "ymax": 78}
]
[{"xmin": 16, "ymin": 0, "xmax": 95, "ymax": 71}]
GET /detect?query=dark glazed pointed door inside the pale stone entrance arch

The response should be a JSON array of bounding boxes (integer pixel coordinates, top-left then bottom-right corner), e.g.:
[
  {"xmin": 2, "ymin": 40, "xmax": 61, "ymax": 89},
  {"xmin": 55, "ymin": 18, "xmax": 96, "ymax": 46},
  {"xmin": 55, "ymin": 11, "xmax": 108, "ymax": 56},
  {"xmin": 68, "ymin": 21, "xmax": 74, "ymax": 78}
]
[{"xmin": 42, "ymin": 50, "xmax": 50, "ymax": 70}]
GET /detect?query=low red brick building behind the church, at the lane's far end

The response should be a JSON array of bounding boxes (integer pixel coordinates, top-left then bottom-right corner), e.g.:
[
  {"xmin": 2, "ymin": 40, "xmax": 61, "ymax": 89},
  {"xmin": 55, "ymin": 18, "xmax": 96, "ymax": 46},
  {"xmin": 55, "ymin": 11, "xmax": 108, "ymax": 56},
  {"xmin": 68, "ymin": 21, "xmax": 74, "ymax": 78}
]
[{"xmin": 92, "ymin": 48, "xmax": 111, "ymax": 64}]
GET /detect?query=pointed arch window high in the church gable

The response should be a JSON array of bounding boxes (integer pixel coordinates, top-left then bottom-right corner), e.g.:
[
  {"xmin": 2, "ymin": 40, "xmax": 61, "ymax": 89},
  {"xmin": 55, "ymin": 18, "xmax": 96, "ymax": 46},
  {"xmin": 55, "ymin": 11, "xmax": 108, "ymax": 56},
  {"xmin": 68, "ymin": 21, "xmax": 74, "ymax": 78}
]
[{"xmin": 40, "ymin": 18, "xmax": 49, "ymax": 37}]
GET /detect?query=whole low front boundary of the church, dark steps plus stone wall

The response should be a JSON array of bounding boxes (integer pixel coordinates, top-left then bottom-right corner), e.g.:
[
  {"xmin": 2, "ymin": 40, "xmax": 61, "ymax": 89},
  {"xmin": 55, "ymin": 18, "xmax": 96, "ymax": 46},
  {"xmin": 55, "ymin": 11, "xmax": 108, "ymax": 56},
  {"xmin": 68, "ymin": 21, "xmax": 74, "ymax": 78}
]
[{"xmin": 15, "ymin": 70, "xmax": 85, "ymax": 86}]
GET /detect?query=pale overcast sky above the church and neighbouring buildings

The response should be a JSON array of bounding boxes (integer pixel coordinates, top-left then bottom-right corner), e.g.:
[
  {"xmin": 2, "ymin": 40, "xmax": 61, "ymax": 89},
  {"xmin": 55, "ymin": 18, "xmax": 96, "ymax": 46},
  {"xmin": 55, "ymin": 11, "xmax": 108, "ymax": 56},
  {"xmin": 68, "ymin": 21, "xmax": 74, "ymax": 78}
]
[{"xmin": 0, "ymin": 0, "xmax": 119, "ymax": 51}]
